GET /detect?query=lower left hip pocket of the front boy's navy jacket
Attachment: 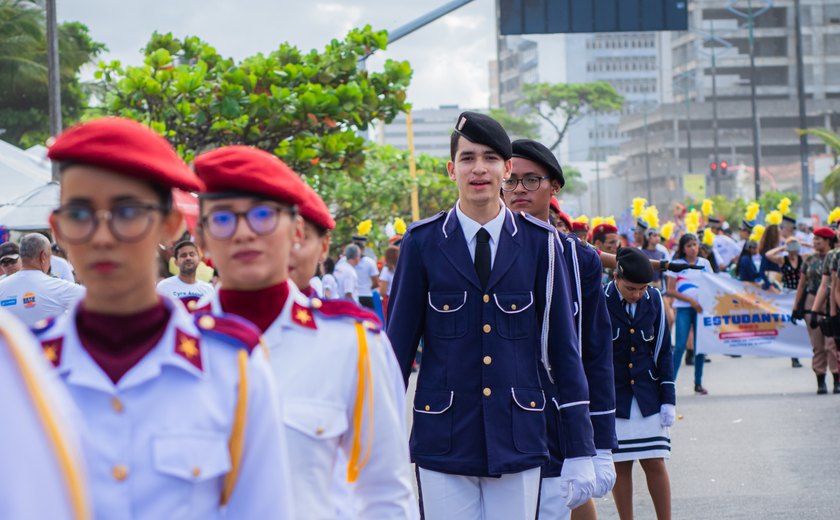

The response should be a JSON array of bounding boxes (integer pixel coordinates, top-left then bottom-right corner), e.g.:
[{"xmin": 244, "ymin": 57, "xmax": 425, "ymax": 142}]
[{"xmin": 411, "ymin": 389, "xmax": 455, "ymax": 455}]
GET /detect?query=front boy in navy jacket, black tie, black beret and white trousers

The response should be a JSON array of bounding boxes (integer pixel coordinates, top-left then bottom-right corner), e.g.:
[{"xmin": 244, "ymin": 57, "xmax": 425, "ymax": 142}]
[{"xmin": 388, "ymin": 112, "xmax": 595, "ymax": 520}]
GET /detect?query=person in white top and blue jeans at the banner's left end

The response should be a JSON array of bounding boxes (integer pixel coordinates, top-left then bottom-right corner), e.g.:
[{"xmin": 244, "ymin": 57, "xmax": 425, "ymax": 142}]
[{"xmin": 666, "ymin": 233, "xmax": 714, "ymax": 395}]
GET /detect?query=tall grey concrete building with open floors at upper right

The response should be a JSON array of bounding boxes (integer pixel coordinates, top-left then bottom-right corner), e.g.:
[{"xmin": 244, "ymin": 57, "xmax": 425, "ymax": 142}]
[{"xmin": 614, "ymin": 0, "xmax": 840, "ymax": 211}]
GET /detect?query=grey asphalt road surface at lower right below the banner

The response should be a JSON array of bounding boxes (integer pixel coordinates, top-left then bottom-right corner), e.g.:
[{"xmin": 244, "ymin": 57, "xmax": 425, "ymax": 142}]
[{"xmin": 409, "ymin": 355, "xmax": 840, "ymax": 520}]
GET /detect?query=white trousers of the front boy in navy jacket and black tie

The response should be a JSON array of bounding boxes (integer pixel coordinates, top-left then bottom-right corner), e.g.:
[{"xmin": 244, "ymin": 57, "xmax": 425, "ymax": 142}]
[{"xmin": 417, "ymin": 468, "xmax": 540, "ymax": 520}]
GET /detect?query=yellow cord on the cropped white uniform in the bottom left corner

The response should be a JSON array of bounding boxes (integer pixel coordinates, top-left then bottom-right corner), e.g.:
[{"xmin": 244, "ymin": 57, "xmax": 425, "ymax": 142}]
[{"xmin": 0, "ymin": 328, "xmax": 92, "ymax": 520}]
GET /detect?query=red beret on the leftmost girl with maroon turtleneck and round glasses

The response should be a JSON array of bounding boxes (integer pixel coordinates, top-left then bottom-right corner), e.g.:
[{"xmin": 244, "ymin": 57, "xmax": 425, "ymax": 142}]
[{"xmin": 47, "ymin": 117, "xmax": 203, "ymax": 191}]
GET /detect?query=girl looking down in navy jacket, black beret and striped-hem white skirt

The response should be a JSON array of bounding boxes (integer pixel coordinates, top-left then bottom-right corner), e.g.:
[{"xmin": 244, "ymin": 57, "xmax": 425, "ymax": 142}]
[{"xmin": 605, "ymin": 247, "xmax": 676, "ymax": 519}]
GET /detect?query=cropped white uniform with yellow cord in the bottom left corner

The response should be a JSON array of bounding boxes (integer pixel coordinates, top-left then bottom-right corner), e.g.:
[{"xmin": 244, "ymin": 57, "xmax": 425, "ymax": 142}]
[{"xmin": 0, "ymin": 310, "xmax": 90, "ymax": 520}]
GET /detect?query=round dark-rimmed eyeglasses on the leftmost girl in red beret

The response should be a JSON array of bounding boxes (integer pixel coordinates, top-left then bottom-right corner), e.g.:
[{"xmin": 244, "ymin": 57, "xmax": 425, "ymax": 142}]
[{"xmin": 53, "ymin": 203, "xmax": 163, "ymax": 245}]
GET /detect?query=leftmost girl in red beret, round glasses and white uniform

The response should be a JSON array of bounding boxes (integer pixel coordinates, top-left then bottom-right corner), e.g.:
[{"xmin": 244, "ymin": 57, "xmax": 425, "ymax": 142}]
[{"xmin": 41, "ymin": 118, "xmax": 292, "ymax": 519}]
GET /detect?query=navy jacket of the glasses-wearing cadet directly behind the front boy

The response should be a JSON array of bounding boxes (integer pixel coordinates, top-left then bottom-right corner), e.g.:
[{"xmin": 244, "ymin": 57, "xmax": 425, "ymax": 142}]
[{"xmin": 542, "ymin": 233, "xmax": 618, "ymax": 478}]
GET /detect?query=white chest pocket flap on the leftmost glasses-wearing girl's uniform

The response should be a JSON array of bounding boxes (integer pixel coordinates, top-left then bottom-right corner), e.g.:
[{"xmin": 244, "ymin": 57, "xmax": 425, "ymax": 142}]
[{"xmin": 152, "ymin": 432, "xmax": 230, "ymax": 482}]
